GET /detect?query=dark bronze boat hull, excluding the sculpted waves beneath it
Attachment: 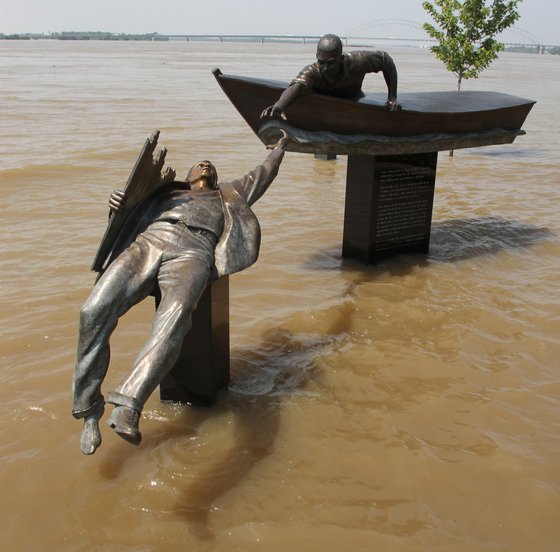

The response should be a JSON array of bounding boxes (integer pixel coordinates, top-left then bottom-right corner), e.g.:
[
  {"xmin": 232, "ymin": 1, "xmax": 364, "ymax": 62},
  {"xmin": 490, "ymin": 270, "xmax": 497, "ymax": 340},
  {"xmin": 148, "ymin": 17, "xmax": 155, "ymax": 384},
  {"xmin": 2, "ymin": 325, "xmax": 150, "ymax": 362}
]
[{"xmin": 214, "ymin": 69, "xmax": 535, "ymax": 153}]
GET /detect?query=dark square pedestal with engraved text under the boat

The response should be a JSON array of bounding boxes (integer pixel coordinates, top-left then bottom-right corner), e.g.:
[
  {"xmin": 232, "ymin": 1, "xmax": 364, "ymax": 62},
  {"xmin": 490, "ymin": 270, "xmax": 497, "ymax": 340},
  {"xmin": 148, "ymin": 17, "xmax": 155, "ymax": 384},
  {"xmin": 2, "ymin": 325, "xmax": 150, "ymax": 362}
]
[{"xmin": 342, "ymin": 152, "xmax": 437, "ymax": 264}]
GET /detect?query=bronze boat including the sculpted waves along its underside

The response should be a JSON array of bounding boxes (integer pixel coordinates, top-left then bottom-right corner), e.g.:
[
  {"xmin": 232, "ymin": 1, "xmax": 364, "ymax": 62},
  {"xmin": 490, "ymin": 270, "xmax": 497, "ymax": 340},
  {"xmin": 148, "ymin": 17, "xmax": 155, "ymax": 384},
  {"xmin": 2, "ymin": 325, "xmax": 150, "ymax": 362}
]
[{"xmin": 213, "ymin": 69, "xmax": 535, "ymax": 154}]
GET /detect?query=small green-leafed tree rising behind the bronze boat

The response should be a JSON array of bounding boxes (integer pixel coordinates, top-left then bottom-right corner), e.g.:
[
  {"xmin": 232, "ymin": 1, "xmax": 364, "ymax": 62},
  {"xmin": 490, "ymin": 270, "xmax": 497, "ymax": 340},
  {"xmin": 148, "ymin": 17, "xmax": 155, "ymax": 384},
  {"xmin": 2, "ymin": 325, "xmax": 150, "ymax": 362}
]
[{"xmin": 422, "ymin": 0, "xmax": 522, "ymax": 92}]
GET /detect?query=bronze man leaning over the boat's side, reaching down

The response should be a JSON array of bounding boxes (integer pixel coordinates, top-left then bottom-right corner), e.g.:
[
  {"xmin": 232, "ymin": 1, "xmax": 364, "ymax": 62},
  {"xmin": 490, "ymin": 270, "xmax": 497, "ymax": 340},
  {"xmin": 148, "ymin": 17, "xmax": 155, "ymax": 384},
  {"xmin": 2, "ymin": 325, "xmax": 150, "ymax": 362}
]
[{"xmin": 261, "ymin": 34, "xmax": 399, "ymax": 120}]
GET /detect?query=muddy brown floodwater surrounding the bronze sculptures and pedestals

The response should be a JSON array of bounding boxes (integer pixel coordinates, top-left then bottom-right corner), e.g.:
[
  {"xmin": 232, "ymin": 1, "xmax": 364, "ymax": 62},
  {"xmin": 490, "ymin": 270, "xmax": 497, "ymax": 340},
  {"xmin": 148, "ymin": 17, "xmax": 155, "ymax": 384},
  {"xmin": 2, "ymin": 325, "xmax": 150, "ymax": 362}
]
[{"xmin": 0, "ymin": 41, "xmax": 560, "ymax": 552}]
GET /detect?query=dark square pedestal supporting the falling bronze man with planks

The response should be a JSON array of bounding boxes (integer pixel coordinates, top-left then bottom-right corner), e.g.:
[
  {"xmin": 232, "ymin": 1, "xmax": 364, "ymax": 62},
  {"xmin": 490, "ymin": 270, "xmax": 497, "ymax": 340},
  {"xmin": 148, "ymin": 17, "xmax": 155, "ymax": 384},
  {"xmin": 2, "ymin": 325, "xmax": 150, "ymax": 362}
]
[{"xmin": 160, "ymin": 276, "xmax": 230, "ymax": 405}]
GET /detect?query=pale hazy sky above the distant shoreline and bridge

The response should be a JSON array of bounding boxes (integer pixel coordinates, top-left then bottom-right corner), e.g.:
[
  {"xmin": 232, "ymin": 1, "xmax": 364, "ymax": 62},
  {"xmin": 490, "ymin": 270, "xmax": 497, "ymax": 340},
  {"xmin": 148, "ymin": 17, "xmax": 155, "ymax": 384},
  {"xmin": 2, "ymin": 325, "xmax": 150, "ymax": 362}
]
[{"xmin": 0, "ymin": 0, "xmax": 560, "ymax": 45}]
